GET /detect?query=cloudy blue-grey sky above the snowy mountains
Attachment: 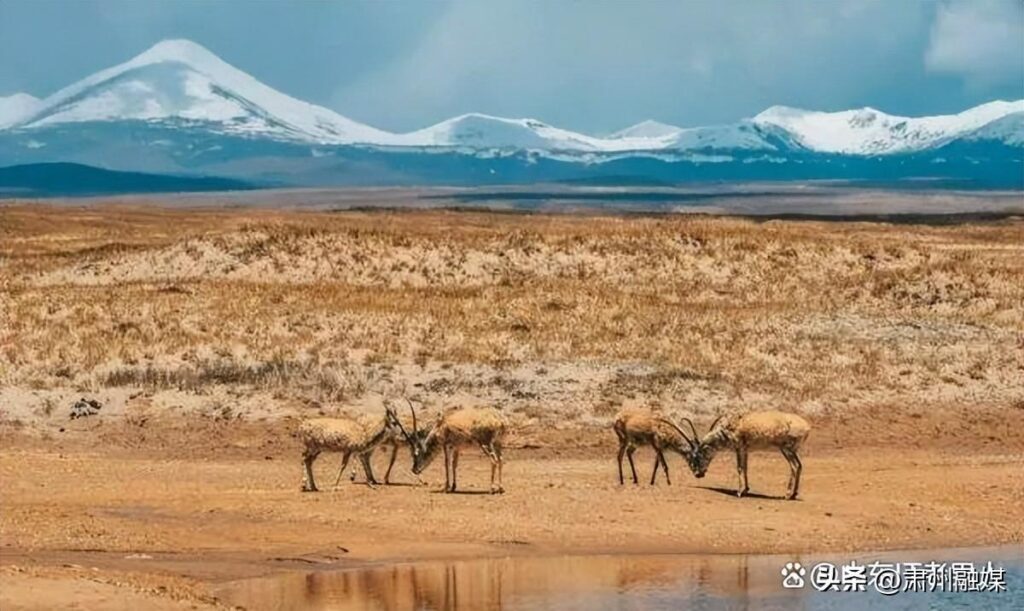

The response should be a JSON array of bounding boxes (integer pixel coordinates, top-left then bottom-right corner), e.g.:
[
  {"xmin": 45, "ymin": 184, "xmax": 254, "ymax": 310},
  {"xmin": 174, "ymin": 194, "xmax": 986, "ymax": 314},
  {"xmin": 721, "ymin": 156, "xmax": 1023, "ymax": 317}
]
[{"xmin": 0, "ymin": 0, "xmax": 1024, "ymax": 133}]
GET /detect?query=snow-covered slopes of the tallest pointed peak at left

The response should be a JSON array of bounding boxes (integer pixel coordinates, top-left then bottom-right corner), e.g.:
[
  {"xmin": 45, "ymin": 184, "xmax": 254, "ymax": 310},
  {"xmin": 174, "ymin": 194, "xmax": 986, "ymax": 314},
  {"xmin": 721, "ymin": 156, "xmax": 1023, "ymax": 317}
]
[{"xmin": 17, "ymin": 40, "xmax": 391, "ymax": 143}]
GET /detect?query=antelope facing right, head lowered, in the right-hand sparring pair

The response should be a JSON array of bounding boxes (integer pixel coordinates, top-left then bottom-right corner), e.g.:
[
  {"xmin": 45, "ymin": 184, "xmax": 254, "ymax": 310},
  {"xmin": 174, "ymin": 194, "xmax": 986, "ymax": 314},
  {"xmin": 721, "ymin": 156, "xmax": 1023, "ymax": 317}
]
[{"xmin": 611, "ymin": 407, "xmax": 695, "ymax": 486}]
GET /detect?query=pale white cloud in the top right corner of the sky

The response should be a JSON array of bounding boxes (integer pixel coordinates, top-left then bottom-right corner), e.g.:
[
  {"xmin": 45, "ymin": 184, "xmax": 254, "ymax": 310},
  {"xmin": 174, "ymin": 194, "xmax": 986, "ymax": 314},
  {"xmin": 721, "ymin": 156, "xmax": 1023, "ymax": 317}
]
[{"xmin": 925, "ymin": 0, "xmax": 1024, "ymax": 87}]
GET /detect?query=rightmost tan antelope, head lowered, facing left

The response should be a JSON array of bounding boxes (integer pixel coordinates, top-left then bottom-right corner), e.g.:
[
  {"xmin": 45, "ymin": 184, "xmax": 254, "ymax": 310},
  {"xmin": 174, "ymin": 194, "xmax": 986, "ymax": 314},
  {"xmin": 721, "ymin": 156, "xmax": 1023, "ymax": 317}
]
[{"xmin": 690, "ymin": 411, "xmax": 811, "ymax": 500}]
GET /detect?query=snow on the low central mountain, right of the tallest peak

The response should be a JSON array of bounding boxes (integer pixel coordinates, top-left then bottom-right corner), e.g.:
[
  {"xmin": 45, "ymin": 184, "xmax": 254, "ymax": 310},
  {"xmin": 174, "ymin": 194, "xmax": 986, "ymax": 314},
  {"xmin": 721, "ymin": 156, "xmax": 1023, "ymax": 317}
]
[{"xmin": 390, "ymin": 114, "xmax": 664, "ymax": 151}]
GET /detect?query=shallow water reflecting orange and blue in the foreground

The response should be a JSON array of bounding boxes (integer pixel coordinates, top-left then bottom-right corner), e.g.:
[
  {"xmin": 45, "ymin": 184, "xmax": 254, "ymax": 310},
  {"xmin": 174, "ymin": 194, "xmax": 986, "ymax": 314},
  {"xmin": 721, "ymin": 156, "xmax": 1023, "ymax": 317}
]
[{"xmin": 218, "ymin": 545, "xmax": 1024, "ymax": 611}]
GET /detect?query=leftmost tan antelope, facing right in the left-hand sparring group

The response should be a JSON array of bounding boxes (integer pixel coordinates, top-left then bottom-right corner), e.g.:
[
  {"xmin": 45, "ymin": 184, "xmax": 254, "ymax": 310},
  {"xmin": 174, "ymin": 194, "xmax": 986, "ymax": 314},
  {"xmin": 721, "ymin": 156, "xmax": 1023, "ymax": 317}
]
[{"xmin": 298, "ymin": 407, "xmax": 400, "ymax": 492}]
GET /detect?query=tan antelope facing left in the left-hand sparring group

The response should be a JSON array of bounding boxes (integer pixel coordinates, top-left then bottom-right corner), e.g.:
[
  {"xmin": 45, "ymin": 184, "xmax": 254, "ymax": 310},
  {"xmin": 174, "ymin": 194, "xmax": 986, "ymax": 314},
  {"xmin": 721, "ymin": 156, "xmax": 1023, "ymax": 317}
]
[{"xmin": 399, "ymin": 404, "xmax": 508, "ymax": 493}]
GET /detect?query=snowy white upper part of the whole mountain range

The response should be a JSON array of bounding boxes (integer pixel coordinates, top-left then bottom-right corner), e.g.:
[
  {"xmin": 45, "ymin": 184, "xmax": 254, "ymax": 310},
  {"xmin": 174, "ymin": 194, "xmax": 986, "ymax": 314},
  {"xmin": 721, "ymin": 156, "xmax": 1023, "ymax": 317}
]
[{"xmin": 0, "ymin": 40, "xmax": 1024, "ymax": 156}]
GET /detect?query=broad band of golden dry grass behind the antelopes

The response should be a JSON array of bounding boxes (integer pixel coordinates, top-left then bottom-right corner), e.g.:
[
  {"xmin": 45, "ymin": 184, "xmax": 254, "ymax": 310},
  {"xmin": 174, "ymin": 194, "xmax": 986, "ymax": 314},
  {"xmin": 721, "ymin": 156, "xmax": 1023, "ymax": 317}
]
[{"xmin": 0, "ymin": 206, "xmax": 1024, "ymax": 420}]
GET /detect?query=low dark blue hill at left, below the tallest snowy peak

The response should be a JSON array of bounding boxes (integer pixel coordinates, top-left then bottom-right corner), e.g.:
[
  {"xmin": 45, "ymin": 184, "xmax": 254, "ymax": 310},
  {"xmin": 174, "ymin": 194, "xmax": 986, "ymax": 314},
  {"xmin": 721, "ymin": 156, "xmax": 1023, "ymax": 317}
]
[{"xmin": 0, "ymin": 163, "xmax": 256, "ymax": 198}]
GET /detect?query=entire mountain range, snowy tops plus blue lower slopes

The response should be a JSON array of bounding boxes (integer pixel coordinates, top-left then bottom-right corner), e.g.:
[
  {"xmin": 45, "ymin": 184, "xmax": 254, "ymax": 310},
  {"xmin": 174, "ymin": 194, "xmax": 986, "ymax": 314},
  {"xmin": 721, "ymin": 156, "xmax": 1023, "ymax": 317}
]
[{"xmin": 0, "ymin": 40, "xmax": 1024, "ymax": 188}]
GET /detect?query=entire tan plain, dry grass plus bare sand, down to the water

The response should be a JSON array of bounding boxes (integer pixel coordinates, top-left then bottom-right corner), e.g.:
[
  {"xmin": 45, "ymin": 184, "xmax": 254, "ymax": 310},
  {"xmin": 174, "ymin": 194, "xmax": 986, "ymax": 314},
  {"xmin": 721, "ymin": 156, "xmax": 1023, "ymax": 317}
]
[{"xmin": 0, "ymin": 195, "xmax": 1024, "ymax": 610}]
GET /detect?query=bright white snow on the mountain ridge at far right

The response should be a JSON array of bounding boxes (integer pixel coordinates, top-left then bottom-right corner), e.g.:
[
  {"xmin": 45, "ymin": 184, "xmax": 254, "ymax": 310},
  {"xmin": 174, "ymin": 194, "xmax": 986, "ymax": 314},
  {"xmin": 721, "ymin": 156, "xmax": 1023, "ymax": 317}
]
[{"xmin": 753, "ymin": 100, "xmax": 1024, "ymax": 155}]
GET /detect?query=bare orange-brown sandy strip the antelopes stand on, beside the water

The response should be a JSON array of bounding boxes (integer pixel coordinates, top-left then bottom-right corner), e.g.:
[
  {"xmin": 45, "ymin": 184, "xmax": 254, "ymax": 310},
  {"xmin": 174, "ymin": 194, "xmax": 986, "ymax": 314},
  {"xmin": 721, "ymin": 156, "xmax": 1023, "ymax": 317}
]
[{"xmin": 0, "ymin": 412, "xmax": 1024, "ymax": 609}]
